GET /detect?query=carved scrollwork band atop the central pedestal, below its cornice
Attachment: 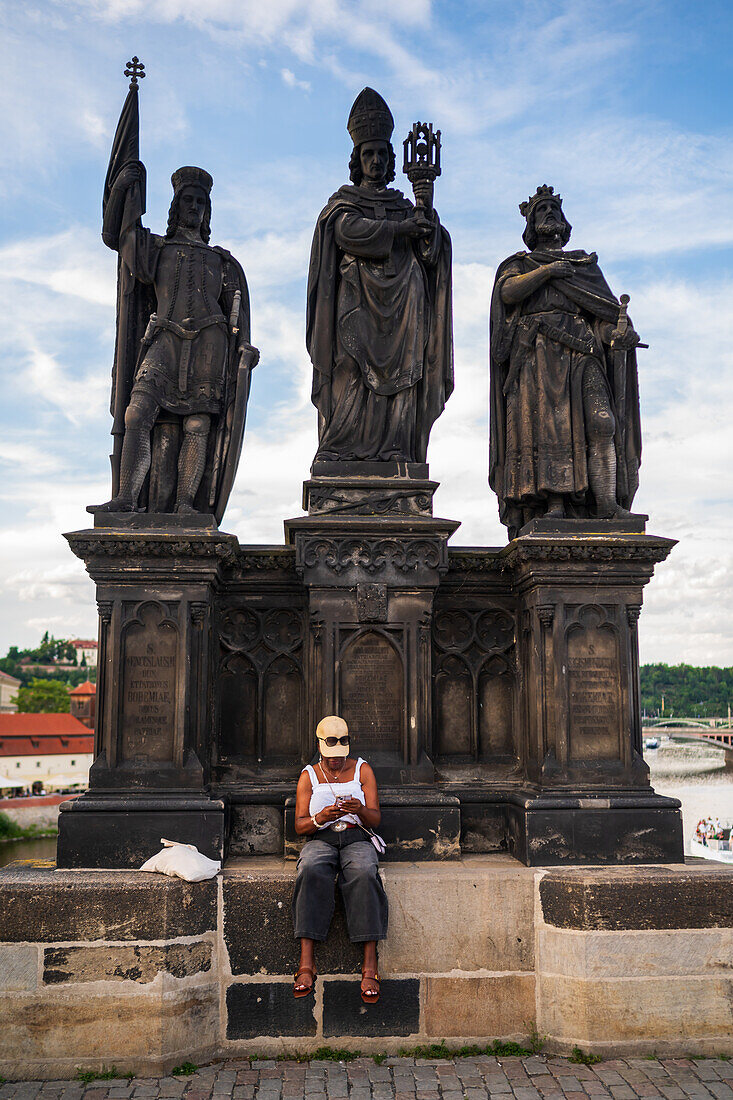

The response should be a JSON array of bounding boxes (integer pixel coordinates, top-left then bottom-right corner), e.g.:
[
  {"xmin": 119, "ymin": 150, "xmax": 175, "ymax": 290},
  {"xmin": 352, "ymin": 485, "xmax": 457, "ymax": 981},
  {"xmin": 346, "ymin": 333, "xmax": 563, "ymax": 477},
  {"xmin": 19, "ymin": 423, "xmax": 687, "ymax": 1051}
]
[{"xmin": 296, "ymin": 535, "xmax": 447, "ymax": 576}]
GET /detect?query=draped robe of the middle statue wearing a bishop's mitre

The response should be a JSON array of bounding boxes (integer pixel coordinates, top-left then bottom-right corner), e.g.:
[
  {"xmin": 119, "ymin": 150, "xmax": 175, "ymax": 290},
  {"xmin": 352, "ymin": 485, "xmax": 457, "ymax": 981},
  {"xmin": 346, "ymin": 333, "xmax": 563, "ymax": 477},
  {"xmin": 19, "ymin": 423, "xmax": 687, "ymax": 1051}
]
[{"xmin": 306, "ymin": 185, "xmax": 453, "ymax": 462}]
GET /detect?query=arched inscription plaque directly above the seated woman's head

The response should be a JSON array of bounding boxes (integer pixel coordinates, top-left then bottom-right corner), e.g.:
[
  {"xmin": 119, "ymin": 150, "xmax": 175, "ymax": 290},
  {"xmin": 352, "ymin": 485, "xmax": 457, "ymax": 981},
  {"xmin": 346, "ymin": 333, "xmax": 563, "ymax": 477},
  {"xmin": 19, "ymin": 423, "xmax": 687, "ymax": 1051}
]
[{"xmin": 340, "ymin": 631, "xmax": 405, "ymax": 755}]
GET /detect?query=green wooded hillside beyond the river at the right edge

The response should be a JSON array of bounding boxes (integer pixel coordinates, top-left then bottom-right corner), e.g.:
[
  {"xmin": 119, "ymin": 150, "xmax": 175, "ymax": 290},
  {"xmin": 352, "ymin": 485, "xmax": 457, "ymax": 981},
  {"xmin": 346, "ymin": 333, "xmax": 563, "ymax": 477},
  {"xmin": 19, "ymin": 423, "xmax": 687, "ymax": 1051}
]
[{"xmin": 641, "ymin": 664, "xmax": 733, "ymax": 718}]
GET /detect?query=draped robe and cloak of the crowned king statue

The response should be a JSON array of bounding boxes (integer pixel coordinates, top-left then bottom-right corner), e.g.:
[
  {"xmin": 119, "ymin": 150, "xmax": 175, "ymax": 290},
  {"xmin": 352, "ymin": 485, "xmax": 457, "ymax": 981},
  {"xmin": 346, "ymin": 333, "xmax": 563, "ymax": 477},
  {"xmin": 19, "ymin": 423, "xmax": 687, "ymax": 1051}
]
[{"xmin": 489, "ymin": 250, "xmax": 642, "ymax": 530}]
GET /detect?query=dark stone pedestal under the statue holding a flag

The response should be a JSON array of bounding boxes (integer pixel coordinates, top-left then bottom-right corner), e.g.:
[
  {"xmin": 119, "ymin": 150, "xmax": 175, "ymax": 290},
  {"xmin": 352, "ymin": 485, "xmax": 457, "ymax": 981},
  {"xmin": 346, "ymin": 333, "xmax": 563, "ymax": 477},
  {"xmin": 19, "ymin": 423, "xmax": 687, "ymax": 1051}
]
[{"xmin": 58, "ymin": 516, "xmax": 237, "ymax": 867}]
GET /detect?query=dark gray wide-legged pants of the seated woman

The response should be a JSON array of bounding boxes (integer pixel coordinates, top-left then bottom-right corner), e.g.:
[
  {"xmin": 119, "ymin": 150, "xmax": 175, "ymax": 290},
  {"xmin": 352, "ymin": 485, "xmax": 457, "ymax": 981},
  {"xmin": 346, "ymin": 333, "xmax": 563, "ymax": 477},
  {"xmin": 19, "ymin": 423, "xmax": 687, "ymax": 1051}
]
[{"xmin": 293, "ymin": 829, "xmax": 389, "ymax": 944}]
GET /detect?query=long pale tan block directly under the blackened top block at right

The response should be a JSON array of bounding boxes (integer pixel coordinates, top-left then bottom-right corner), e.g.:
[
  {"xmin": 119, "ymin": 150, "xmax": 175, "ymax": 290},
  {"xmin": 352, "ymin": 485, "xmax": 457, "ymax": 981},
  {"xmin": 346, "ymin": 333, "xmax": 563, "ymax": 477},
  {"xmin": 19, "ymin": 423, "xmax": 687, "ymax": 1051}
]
[{"xmin": 538, "ymin": 926, "xmax": 733, "ymax": 980}]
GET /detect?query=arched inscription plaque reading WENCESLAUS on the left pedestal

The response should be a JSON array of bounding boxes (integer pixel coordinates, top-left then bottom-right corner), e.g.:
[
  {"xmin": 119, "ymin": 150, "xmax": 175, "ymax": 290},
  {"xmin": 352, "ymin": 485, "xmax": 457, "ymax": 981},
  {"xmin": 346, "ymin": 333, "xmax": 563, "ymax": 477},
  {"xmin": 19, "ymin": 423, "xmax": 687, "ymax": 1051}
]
[{"xmin": 120, "ymin": 604, "xmax": 178, "ymax": 761}]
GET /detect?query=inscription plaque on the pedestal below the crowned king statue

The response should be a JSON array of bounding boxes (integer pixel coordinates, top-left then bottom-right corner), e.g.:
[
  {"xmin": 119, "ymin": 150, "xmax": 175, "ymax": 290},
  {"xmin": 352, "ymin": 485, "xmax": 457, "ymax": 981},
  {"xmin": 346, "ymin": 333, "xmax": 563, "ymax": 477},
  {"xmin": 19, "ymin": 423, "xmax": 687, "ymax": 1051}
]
[{"xmin": 568, "ymin": 627, "xmax": 620, "ymax": 760}]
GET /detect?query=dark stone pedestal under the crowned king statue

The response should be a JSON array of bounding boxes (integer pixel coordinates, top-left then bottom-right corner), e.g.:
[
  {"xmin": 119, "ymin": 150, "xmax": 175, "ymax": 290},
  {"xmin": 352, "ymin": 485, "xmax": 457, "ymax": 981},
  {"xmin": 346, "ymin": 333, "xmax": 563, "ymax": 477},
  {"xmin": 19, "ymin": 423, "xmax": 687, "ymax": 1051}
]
[{"xmin": 503, "ymin": 517, "xmax": 682, "ymax": 866}]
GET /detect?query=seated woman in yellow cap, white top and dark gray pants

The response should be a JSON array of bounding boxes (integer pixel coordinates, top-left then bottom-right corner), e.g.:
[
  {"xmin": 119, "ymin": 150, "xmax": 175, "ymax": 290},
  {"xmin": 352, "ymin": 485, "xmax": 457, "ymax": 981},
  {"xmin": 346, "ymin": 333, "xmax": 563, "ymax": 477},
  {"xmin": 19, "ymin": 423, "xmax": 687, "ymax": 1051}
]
[{"xmin": 293, "ymin": 715, "xmax": 387, "ymax": 1004}]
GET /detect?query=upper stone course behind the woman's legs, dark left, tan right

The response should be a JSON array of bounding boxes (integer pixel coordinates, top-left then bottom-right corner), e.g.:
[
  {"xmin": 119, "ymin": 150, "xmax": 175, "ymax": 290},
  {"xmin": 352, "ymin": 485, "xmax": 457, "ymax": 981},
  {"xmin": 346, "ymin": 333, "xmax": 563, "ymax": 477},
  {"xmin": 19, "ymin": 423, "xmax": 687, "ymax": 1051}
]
[{"xmin": 223, "ymin": 856, "xmax": 535, "ymax": 977}]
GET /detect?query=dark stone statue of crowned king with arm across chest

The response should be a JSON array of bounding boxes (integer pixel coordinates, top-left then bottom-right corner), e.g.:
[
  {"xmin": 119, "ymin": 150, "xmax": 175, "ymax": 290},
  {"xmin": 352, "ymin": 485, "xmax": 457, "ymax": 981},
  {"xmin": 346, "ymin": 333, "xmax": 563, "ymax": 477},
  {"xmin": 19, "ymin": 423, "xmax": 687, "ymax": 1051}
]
[{"xmin": 489, "ymin": 185, "xmax": 646, "ymax": 538}]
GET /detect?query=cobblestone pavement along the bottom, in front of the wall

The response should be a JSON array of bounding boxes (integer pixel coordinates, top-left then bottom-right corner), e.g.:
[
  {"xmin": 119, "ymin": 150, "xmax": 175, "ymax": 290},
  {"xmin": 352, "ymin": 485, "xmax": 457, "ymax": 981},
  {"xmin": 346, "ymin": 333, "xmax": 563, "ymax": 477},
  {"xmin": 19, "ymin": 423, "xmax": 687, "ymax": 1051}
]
[{"xmin": 0, "ymin": 1055, "xmax": 733, "ymax": 1100}]
